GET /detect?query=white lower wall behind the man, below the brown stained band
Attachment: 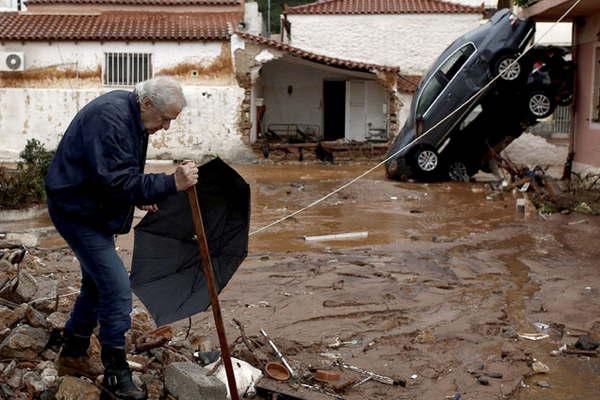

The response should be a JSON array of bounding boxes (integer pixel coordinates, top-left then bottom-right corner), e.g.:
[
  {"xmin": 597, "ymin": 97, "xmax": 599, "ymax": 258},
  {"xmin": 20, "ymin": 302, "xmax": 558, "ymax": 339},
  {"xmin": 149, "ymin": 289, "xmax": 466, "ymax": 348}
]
[{"xmin": 0, "ymin": 86, "xmax": 249, "ymax": 160}]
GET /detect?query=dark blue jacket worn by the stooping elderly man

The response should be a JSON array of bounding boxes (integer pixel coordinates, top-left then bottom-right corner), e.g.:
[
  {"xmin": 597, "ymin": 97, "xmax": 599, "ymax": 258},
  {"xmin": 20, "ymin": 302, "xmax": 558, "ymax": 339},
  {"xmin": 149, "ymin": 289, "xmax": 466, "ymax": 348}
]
[{"xmin": 46, "ymin": 90, "xmax": 177, "ymax": 233}]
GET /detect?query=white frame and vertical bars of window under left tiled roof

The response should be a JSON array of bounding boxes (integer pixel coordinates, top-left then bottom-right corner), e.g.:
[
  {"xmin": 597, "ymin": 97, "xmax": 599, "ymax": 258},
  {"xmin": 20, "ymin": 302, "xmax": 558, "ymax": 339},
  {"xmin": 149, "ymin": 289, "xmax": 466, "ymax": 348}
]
[{"xmin": 102, "ymin": 51, "xmax": 154, "ymax": 87}]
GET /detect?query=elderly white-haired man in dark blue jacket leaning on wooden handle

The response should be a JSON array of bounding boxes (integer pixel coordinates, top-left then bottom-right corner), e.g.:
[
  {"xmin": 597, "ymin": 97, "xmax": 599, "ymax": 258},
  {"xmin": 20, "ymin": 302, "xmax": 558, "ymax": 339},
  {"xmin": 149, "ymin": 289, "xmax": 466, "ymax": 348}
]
[{"xmin": 46, "ymin": 77, "xmax": 198, "ymax": 400}]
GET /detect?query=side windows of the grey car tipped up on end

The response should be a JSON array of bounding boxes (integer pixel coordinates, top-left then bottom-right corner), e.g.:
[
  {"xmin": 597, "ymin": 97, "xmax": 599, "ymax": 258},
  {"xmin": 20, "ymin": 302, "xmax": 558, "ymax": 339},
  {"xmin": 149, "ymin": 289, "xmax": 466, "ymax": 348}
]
[{"xmin": 417, "ymin": 43, "xmax": 475, "ymax": 115}]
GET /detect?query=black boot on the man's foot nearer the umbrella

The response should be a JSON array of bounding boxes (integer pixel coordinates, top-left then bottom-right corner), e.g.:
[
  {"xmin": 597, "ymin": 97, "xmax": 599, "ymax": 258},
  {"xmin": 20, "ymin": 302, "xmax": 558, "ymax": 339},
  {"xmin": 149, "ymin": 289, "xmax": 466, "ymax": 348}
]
[{"xmin": 100, "ymin": 346, "xmax": 147, "ymax": 400}]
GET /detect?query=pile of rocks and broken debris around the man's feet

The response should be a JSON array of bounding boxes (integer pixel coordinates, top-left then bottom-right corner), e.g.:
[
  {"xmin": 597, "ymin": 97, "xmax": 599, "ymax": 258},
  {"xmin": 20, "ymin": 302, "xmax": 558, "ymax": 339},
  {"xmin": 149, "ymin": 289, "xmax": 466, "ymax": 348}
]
[{"xmin": 0, "ymin": 245, "xmax": 406, "ymax": 400}]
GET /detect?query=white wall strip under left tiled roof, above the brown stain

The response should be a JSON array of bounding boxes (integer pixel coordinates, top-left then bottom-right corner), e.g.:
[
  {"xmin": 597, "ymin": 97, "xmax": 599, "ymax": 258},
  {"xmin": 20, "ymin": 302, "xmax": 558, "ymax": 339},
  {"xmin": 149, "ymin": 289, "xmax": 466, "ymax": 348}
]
[{"xmin": 0, "ymin": 41, "xmax": 226, "ymax": 72}]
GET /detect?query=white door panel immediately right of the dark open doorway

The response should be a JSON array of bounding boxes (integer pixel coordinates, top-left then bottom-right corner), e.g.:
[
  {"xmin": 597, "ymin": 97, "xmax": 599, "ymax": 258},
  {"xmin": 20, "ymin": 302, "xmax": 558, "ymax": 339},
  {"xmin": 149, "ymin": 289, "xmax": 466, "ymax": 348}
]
[{"xmin": 346, "ymin": 81, "xmax": 367, "ymax": 142}]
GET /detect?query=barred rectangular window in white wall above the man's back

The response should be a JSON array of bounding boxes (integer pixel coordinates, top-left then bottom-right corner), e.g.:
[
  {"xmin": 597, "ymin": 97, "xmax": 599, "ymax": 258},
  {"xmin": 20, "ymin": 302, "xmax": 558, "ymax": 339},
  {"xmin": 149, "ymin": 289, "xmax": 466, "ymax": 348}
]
[{"xmin": 103, "ymin": 53, "xmax": 152, "ymax": 86}]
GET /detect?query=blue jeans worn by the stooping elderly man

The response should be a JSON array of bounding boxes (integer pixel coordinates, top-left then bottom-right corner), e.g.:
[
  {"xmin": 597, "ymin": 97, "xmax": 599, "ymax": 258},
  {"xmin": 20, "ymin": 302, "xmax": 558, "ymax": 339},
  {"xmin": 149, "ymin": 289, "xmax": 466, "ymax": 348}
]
[{"xmin": 48, "ymin": 200, "xmax": 132, "ymax": 347}]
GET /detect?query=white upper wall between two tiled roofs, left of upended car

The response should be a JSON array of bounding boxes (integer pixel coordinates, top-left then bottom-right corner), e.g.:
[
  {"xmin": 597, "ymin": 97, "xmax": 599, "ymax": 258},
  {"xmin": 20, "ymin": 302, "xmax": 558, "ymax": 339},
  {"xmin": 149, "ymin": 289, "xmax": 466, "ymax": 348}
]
[{"xmin": 288, "ymin": 14, "xmax": 482, "ymax": 74}]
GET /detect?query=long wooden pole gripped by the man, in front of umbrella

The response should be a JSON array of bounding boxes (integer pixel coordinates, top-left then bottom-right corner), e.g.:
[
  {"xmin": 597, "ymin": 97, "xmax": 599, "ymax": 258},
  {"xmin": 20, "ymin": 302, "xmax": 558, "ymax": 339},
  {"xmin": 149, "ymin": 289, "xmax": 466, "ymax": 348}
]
[{"xmin": 187, "ymin": 186, "xmax": 239, "ymax": 400}]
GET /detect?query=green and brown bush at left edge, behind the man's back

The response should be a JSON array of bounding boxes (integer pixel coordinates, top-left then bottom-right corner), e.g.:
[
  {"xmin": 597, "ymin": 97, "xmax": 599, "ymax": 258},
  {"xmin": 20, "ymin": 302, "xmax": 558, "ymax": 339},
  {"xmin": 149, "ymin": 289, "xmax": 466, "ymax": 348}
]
[{"xmin": 0, "ymin": 139, "xmax": 54, "ymax": 209}]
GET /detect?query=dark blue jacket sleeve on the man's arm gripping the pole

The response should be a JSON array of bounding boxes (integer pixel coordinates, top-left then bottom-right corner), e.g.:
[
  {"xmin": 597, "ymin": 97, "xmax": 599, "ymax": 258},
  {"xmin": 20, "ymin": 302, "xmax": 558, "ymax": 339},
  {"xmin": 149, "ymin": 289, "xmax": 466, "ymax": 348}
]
[{"xmin": 82, "ymin": 109, "xmax": 177, "ymax": 205}]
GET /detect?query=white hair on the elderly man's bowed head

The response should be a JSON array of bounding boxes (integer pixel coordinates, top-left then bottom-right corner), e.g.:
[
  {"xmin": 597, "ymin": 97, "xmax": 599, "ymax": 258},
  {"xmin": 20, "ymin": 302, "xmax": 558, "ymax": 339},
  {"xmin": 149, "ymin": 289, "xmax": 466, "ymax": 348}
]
[{"xmin": 135, "ymin": 76, "xmax": 187, "ymax": 111}]
